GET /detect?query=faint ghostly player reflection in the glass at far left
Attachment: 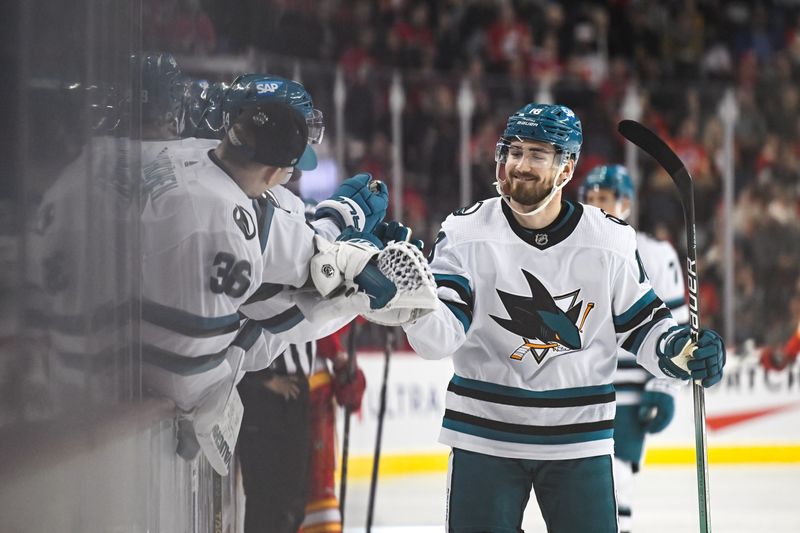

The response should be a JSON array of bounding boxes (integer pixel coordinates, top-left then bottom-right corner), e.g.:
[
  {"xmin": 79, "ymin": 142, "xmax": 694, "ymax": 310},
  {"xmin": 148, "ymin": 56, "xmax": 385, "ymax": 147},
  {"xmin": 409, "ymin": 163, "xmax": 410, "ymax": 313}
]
[{"xmin": 23, "ymin": 82, "xmax": 131, "ymax": 404}]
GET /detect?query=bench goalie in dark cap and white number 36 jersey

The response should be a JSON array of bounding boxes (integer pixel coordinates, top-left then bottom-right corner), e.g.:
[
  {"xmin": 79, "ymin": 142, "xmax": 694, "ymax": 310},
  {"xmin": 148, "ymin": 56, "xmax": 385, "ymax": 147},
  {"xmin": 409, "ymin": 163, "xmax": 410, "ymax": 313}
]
[{"xmin": 142, "ymin": 71, "xmax": 434, "ymax": 470}]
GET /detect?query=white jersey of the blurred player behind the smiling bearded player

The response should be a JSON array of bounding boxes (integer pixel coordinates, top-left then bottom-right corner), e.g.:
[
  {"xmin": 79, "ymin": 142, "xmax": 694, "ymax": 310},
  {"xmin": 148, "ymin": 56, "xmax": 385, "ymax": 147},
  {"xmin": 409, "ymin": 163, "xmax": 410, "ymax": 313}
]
[{"xmin": 614, "ymin": 232, "xmax": 689, "ymax": 405}]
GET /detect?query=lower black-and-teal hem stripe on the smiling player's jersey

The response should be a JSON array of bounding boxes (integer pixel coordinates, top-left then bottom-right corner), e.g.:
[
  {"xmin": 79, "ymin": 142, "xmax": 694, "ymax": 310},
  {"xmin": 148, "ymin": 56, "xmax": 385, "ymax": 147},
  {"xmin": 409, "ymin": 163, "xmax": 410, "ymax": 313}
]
[{"xmin": 442, "ymin": 409, "xmax": 614, "ymax": 444}]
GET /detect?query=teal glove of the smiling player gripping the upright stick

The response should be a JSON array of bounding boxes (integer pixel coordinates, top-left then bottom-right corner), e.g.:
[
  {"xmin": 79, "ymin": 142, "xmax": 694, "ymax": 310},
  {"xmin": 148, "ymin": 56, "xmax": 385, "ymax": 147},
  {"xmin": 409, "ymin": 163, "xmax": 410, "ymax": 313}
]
[{"xmin": 656, "ymin": 326, "xmax": 725, "ymax": 388}]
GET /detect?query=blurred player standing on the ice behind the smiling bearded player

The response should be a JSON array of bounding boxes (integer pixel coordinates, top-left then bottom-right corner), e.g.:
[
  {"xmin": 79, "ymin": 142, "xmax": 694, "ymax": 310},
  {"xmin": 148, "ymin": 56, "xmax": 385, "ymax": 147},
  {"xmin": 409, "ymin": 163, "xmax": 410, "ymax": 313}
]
[{"xmin": 580, "ymin": 165, "xmax": 689, "ymax": 533}]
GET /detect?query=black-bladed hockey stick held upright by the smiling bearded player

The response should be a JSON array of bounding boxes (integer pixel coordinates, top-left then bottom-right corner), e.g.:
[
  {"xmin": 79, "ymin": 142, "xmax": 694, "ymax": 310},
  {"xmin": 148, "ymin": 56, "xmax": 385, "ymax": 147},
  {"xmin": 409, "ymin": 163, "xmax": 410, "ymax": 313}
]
[{"xmin": 618, "ymin": 120, "xmax": 711, "ymax": 533}]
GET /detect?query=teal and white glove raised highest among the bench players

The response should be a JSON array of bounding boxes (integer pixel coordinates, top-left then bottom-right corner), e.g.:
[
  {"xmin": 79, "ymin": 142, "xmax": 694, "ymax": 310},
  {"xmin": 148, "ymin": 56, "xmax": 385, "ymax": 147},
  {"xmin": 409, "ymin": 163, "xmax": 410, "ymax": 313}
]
[{"xmin": 314, "ymin": 173, "xmax": 389, "ymax": 233}]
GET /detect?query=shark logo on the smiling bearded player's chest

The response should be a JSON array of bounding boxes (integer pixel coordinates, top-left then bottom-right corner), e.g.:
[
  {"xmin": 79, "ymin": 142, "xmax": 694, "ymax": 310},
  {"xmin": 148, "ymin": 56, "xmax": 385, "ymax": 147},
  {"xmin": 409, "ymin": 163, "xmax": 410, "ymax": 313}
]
[{"xmin": 489, "ymin": 270, "xmax": 594, "ymax": 364}]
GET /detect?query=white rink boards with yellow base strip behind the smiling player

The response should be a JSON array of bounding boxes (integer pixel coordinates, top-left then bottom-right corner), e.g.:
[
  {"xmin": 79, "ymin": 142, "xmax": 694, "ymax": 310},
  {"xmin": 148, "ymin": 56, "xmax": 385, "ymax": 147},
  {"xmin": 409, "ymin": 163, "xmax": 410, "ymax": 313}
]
[{"xmin": 339, "ymin": 352, "xmax": 800, "ymax": 476}]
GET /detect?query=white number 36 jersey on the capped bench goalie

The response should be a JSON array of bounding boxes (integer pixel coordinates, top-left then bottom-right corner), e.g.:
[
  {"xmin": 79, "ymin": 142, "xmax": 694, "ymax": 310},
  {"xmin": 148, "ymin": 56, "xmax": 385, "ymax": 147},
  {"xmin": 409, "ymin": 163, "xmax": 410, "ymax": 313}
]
[{"xmin": 141, "ymin": 145, "xmax": 264, "ymax": 409}]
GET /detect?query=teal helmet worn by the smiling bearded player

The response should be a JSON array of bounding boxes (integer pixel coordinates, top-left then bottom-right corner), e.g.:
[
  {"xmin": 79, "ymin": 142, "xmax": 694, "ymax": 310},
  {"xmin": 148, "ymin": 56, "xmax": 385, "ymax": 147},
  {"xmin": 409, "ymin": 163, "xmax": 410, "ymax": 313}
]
[{"xmin": 495, "ymin": 103, "xmax": 583, "ymax": 165}]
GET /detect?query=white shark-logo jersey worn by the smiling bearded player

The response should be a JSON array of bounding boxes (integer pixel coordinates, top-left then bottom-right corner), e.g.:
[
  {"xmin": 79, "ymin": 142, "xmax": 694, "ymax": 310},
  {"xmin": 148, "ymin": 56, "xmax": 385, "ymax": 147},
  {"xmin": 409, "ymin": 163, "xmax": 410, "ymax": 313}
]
[{"xmin": 405, "ymin": 198, "xmax": 675, "ymax": 459}]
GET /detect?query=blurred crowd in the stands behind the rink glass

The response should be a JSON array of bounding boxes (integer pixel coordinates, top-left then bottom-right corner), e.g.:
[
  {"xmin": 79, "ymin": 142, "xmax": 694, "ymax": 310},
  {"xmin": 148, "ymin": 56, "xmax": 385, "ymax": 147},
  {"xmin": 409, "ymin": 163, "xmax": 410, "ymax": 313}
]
[{"xmin": 145, "ymin": 0, "xmax": 800, "ymax": 352}]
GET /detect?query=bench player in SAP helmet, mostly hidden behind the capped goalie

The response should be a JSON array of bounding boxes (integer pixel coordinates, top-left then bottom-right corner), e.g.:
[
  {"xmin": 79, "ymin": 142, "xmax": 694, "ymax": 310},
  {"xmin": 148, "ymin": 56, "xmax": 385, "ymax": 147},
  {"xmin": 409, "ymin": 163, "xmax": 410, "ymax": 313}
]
[{"xmin": 214, "ymin": 74, "xmax": 432, "ymax": 350}]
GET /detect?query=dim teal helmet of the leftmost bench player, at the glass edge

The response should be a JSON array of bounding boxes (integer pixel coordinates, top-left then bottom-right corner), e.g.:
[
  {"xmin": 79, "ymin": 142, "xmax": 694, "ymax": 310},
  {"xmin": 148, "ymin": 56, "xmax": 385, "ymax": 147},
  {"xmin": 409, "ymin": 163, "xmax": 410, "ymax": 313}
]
[{"xmin": 141, "ymin": 52, "xmax": 185, "ymax": 135}]
